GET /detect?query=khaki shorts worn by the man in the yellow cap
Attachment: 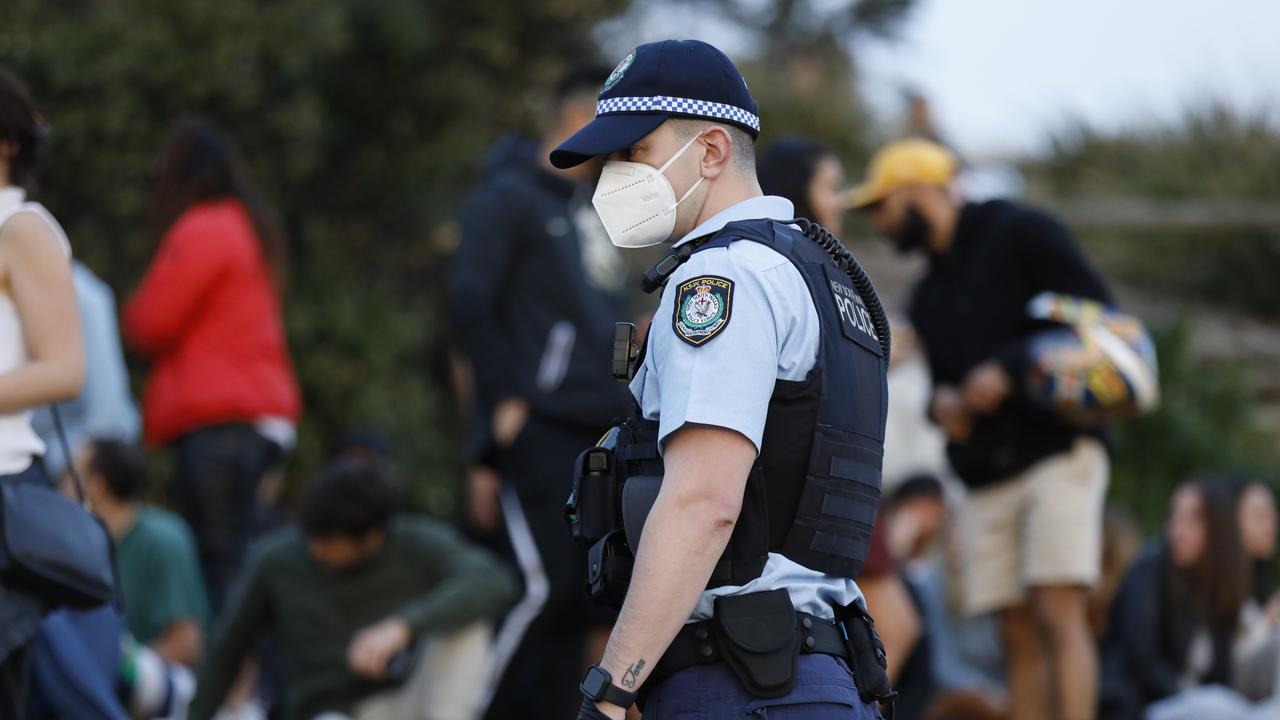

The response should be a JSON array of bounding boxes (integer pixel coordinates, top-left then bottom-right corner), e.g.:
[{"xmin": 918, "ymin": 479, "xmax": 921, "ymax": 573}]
[{"xmin": 964, "ymin": 438, "xmax": 1110, "ymax": 615}]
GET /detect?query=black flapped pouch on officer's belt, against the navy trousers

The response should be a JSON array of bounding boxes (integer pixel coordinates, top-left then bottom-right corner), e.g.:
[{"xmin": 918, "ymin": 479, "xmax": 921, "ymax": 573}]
[{"xmin": 712, "ymin": 589, "xmax": 800, "ymax": 698}]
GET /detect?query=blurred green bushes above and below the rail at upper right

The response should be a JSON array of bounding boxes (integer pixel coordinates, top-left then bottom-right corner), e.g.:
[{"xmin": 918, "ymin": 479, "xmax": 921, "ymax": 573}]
[{"xmin": 1028, "ymin": 106, "xmax": 1280, "ymax": 319}]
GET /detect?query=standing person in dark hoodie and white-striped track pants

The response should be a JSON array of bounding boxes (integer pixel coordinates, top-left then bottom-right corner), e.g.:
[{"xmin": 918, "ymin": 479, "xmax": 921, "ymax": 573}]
[{"xmin": 449, "ymin": 67, "xmax": 630, "ymax": 719}]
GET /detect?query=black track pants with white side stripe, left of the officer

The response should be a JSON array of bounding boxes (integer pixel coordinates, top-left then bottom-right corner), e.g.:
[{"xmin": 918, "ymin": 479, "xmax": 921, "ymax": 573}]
[{"xmin": 485, "ymin": 419, "xmax": 600, "ymax": 720}]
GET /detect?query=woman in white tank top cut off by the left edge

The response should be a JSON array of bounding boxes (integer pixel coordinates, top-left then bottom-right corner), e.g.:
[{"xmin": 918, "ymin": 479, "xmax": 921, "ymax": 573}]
[{"xmin": 0, "ymin": 68, "xmax": 84, "ymax": 720}]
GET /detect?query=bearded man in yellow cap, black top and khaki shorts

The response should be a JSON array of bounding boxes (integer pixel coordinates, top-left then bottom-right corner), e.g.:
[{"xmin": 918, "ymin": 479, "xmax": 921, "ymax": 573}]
[{"xmin": 850, "ymin": 140, "xmax": 1110, "ymax": 720}]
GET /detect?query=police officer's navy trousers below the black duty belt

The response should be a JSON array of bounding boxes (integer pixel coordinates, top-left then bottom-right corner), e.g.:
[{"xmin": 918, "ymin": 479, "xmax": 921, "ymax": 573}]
[{"xmin": 644, "ymin": 655, "xmax": 879, "ymax": 720}]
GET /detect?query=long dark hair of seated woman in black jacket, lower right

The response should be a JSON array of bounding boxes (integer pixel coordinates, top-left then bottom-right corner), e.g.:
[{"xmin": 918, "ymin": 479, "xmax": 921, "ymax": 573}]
[{"xmin": 1184, "ymin": 475, "xmax": 1249, "ymax": 633}]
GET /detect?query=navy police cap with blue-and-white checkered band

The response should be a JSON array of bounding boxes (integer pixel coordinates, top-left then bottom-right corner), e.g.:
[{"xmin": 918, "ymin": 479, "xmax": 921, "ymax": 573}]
[{"xmin": 552, "ymin": 40, "xmax": 760, "ymax": 168}]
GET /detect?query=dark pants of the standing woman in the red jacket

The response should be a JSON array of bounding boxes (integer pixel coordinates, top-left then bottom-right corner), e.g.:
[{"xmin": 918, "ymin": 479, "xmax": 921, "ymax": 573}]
[{"xmin": 175, "ymin": 423, "xmax": 280, "ymax": 614}]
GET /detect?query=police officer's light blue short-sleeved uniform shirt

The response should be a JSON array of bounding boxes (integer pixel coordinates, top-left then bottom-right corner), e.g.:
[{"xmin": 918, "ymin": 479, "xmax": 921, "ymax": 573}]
[{"xmin": 631, "ymin": 196, "xmax": 861, "ymax": 621}]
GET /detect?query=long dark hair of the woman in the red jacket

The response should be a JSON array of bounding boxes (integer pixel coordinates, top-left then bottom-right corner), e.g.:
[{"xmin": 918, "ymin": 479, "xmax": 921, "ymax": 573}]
[{"xmin": 151, "ymin": 115, "xmax": 288, "ymax": 290}]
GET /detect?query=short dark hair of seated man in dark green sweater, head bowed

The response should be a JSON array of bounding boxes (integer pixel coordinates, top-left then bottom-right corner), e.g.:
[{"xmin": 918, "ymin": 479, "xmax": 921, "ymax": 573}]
[{"xmin": 298, "ymin": 457, "xmax": 399, "ymax": 538}]
